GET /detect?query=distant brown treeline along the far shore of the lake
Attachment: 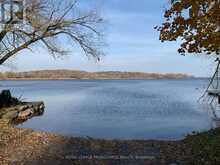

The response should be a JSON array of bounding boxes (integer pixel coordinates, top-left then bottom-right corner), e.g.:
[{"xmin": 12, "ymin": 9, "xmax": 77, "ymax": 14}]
[{"xmin": 0, "ymin": 70, "xmax": 192, "ymax": 80}]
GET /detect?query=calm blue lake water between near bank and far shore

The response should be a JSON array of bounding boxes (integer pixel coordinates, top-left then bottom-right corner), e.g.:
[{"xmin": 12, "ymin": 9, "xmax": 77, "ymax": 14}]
[{"xmin": 0, "ymin": 79, "xmax": 217, "ymax": 139}]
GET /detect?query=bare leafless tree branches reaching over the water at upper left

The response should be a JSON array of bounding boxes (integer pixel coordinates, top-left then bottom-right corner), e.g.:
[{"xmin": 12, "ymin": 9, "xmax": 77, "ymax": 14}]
[{"xmin": 0, "ymin": 0, "xmax": 103, "ymax": 64}]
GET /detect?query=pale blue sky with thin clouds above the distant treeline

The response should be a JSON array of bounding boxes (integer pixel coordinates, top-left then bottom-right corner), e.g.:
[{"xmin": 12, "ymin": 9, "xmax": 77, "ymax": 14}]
[{"xmin": 1, "ymin": 0, "xmax": 213, "ymax": 76}]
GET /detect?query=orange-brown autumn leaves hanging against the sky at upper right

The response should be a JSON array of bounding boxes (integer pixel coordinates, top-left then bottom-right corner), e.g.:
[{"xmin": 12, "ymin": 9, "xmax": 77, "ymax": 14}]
[{"xmin": 155, "ymin": 0, "xmax": 220, "ymax": 55}]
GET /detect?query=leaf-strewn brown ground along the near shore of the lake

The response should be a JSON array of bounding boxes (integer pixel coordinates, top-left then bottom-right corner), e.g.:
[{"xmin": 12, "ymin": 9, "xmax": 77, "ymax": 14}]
[{"xmin": 0, "ymin": 122, "xmax": 220, "ymax": 165}]
